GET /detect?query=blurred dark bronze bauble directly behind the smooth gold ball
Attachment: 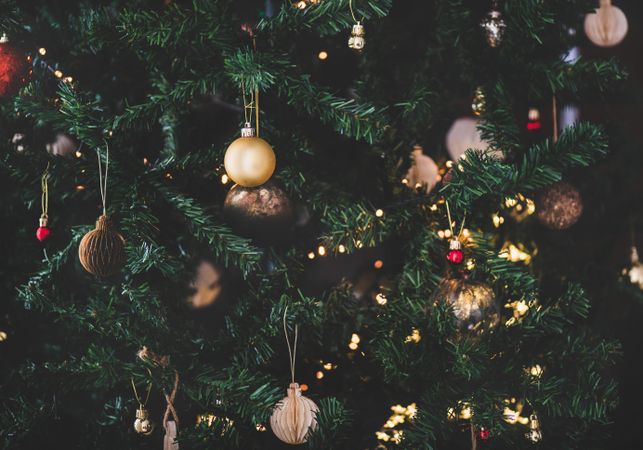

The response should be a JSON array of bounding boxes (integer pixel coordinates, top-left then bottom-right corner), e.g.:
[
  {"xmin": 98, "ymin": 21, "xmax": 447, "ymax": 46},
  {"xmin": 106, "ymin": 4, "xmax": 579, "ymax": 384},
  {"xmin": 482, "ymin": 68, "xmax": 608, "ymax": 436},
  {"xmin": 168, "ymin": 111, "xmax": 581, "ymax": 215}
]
[{"xmin": 223, "ymin": 181, "xmax": 294, "ymax": 241}]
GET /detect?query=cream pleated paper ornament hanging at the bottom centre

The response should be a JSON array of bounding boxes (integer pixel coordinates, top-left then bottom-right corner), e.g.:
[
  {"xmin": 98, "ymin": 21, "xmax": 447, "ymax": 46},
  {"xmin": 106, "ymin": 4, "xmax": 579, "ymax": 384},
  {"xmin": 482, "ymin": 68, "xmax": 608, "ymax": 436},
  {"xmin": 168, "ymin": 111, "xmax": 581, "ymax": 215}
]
[{"xmin": 270, "ymin": 383, "xmax": 319, "ymax": 445}]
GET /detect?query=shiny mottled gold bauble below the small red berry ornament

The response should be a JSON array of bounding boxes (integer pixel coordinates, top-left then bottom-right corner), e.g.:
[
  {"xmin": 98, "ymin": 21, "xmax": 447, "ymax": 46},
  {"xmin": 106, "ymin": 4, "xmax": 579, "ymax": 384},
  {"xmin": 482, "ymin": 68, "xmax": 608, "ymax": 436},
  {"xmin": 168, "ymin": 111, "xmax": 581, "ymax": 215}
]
[{"xmin": 431, "ymin": 278, "xmax": 500, "ymax": 336}]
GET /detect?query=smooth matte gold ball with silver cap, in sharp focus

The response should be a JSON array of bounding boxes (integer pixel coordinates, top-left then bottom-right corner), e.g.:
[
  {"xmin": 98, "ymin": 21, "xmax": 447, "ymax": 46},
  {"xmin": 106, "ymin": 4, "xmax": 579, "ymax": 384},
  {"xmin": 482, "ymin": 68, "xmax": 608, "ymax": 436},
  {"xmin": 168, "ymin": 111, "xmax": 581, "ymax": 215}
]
[{"xmin": 223, "ymin": 124, "xmax": 276, "ymax": 187}]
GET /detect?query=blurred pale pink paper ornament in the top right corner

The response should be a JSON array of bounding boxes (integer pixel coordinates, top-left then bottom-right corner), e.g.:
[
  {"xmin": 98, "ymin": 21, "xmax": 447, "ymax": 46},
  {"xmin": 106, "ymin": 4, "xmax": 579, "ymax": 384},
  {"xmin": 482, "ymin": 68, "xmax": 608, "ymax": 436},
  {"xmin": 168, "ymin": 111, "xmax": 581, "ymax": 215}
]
[{"xmin": 585, "ymin": 0, "xmax": 628, "ymax": 47}]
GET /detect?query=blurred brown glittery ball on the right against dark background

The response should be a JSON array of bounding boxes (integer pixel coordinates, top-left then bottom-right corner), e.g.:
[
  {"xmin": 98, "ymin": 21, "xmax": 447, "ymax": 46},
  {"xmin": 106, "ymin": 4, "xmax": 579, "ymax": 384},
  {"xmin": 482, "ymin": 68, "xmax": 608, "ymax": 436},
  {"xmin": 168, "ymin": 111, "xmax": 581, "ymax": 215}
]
[{"xmin": 536, "ymin": 181, "xmax": 583, "ymax": 230}]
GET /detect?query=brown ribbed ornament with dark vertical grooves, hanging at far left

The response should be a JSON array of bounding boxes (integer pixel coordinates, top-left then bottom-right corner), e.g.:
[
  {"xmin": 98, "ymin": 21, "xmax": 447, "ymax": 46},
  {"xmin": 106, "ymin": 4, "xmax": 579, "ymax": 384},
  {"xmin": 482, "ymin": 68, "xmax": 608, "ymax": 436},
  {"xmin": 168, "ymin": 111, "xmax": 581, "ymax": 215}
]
[{"xmin": 78, "ymin": 215, "xmax": 127, "ymax": 277}]
